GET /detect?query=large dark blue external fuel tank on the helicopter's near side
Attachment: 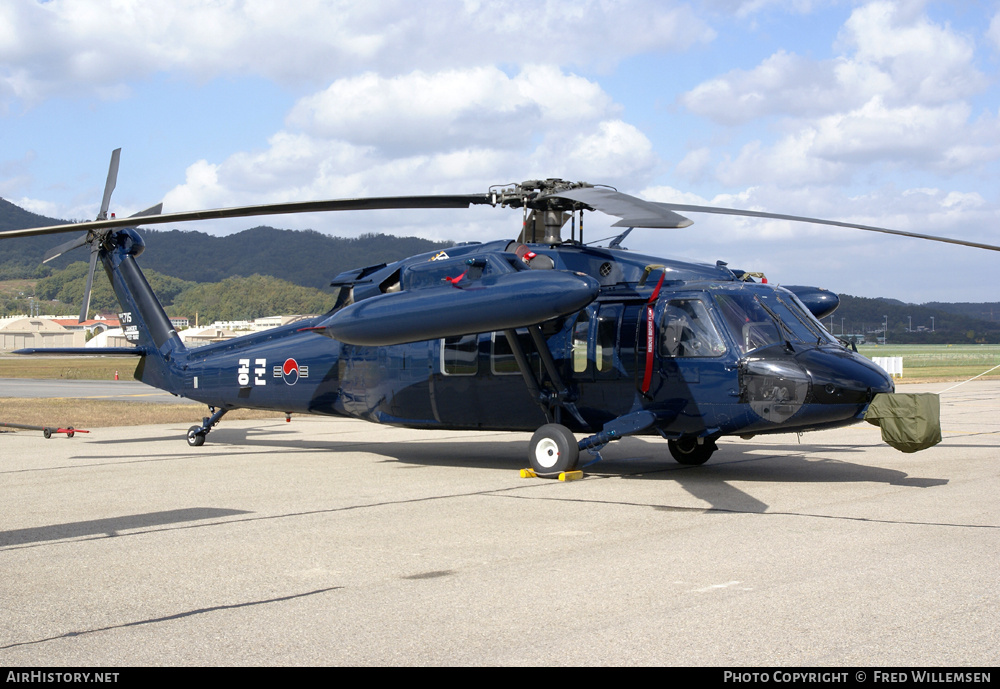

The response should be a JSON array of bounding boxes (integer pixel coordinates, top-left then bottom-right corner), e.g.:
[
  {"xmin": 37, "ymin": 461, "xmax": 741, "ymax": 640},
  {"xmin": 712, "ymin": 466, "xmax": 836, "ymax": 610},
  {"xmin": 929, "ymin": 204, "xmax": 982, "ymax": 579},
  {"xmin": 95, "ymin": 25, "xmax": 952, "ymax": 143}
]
[{"xmin": 315, "ymin": 271, "xmax": 600, "ymax": 347}]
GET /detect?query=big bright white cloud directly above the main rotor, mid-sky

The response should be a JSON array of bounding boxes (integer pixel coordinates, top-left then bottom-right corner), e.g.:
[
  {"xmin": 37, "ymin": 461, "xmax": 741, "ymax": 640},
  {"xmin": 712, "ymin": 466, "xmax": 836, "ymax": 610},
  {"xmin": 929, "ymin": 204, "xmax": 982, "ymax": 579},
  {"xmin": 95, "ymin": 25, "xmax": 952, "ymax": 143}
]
[{"xmin": 165, "ymin": 66, "xmax": 657, "ymax": 231}]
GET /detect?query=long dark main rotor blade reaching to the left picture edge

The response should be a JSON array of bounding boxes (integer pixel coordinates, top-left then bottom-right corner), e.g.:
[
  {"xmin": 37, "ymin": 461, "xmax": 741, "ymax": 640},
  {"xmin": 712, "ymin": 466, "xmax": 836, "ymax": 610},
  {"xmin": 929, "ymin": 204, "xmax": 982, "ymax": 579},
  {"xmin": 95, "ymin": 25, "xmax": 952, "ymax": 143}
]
[{"xmin": 0, "ymin": 194, "xmax": 492, "ymax": 239}]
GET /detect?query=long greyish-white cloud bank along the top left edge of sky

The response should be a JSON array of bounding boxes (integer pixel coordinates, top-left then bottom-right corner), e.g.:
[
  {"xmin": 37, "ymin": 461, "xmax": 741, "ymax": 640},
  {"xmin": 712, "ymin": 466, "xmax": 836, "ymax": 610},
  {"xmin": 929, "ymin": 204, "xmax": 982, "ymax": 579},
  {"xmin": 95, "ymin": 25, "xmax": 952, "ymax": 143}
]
[{"xmin": 0, "ymin": 0, "xmax": 714, "ymax": 104}]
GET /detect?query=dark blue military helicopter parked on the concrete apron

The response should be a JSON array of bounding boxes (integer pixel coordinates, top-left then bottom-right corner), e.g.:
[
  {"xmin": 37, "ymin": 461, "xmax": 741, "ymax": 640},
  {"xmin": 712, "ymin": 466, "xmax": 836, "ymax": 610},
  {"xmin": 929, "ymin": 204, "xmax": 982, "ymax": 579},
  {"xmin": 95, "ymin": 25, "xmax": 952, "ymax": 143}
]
[{"xmin": 0, "ymin": 149, "xmax": 1000, "ymax": 476}]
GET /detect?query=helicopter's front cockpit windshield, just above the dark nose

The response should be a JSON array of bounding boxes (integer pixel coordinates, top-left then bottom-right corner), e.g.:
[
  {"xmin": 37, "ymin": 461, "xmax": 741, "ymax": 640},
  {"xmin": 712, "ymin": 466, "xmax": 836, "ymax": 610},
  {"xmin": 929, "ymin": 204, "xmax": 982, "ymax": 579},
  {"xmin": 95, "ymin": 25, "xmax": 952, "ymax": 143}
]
[{"xmin": 715, "ymin": 291, "xmax": 836, "ymax": 354}]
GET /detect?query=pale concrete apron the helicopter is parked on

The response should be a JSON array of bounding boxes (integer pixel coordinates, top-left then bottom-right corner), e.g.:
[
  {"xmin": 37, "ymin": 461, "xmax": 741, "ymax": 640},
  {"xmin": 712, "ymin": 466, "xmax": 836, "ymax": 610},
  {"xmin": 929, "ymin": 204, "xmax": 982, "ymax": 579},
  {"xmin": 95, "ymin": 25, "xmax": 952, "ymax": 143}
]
[{"xmin": 0, "ymin": 381, "xmax": 1000, "ymax": 668}]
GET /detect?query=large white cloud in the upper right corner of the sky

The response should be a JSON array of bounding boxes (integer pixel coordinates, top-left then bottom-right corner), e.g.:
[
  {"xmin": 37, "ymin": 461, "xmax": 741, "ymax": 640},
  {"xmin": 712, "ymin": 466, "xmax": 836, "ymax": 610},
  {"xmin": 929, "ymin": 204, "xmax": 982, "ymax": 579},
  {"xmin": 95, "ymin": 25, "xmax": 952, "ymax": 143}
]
[{"xmin": 680, "ymin": 1, "xmax": 1000, "ymax": 186}]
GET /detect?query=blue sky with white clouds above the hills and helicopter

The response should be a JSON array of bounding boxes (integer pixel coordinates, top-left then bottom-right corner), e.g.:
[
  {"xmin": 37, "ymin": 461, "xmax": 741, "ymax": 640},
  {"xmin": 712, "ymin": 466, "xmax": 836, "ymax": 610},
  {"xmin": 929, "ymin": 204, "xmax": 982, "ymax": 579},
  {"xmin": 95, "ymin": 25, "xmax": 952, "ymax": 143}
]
[{"xmin": 0, "ymin": 0, "xmax": 1000, "ymax": 303}]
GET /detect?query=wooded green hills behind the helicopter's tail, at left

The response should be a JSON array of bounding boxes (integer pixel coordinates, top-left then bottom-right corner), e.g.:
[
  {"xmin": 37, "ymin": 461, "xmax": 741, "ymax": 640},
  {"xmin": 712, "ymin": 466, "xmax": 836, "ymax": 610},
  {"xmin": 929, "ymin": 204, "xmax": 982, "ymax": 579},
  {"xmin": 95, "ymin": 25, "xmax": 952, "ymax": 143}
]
[{"xmin": 0, "ymin": 199, "xmax": 451, "ymax": 321}]
